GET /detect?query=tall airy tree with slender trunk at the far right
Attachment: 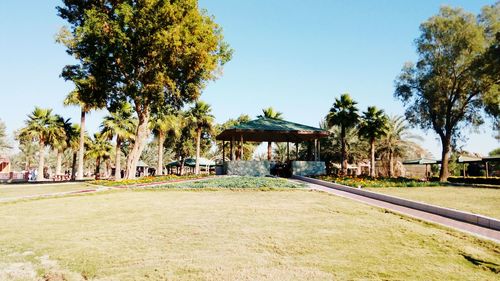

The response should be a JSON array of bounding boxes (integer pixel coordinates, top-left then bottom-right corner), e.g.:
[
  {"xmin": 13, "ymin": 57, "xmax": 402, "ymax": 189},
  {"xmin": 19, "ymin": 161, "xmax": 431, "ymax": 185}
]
[{"xmin": 394, "ymin": 6, "xmax": 500, "ymax": 181}]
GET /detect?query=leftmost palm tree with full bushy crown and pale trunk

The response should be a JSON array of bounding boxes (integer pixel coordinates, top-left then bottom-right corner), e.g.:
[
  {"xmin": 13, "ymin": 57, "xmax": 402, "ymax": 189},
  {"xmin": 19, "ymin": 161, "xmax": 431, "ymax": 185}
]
[{"xmin": 19, "ymin": 107, "xmax": 65, "ymax": 181}]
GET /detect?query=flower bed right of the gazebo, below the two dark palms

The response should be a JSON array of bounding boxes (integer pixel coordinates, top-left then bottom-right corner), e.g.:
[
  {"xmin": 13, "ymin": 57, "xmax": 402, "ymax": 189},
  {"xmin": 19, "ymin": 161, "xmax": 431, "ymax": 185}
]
[{"xmin": 315, "ymin": 176, "xmax": 443, "ymax": 187}]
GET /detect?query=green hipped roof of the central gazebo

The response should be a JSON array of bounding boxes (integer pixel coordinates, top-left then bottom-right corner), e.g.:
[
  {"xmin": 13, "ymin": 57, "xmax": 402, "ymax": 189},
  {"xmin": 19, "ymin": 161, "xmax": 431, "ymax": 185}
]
[{"xmin": 216, "ymin": 118, "xmax": 330, "ymax": 142}]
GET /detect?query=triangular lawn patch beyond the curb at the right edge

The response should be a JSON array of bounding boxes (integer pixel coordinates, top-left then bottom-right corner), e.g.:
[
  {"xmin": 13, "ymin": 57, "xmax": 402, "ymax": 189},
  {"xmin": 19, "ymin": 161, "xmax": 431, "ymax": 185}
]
[{"xmin": 367, "ymin": 186, "xmax": 500, "ymax": 219}]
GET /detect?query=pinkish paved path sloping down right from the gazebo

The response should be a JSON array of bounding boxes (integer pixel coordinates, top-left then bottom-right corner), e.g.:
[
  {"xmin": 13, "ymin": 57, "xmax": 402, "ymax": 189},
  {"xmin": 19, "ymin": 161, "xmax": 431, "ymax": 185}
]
[{"xmin": 300, "ymin": 181, "xmax": 500, "ymax": 243}]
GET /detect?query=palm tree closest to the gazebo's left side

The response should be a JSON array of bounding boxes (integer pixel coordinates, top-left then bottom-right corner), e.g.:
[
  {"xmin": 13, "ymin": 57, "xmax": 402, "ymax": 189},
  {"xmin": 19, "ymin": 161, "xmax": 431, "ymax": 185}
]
[{"xmin": 187, "ymin": 101, "xmax": 214, "ymax": 174}]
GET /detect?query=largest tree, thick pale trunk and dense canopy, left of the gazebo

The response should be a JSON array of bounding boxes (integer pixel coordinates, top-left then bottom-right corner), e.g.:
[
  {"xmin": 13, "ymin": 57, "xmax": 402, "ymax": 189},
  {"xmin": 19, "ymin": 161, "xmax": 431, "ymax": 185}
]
[{"xmin": 58, "ymin": 0, "xmax": 232, "ymax": 178}]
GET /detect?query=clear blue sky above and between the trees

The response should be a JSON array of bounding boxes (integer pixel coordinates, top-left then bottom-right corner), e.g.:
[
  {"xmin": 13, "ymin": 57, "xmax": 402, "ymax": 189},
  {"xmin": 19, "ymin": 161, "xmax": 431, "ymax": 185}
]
[{"xmin": 0, "ymin": 0, "xmax": 499, "ymax": 157}]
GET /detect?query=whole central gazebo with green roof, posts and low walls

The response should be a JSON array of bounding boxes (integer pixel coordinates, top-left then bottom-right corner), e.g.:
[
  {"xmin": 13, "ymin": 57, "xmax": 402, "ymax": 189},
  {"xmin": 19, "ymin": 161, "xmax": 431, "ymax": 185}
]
[{"xmin": 216, "ymin": 117, "xmax": 329, "ymax": 176}]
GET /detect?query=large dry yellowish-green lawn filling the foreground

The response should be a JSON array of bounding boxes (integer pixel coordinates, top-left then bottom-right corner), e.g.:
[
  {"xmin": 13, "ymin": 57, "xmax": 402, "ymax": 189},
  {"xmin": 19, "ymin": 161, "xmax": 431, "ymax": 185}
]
[{"xmin": 0, "ymin": 189, "xmax": 500, "ymax": 280}]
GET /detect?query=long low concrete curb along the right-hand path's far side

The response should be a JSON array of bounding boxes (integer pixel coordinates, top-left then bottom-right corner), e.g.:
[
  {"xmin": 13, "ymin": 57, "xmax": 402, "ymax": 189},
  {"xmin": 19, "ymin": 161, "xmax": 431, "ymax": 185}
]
[{"xmin": 292, "ymin": 176, "xmax": 500, "ymax": 230}]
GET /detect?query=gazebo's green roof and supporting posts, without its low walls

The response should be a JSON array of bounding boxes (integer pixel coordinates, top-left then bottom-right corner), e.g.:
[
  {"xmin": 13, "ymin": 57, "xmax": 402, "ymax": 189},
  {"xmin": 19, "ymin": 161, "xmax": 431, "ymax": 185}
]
[{"xmin": 216, "ymin": 117, "xmax": 330, "ymax": 175}]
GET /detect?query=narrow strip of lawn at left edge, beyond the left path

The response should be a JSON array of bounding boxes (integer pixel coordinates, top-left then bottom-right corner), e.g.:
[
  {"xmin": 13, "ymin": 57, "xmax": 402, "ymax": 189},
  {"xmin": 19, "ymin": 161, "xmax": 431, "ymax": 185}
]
[{"xmin": 0, "ymin": 183, "xmax": 95, "ymax": 201}]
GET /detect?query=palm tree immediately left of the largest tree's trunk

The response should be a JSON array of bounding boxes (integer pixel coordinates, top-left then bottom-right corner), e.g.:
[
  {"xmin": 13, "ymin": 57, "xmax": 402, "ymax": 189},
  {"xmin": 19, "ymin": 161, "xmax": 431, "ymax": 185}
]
[{"xmin": 101, "ymin": 102, "xmax": 137, "ymax": 180}]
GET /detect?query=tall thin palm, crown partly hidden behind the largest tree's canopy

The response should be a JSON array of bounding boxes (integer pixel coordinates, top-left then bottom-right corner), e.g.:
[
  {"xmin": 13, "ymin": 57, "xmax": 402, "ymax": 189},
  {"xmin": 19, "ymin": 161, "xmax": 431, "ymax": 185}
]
[{"xmin": 63, "ymin": 89, "xmax": 105, "ymax": 180}]
